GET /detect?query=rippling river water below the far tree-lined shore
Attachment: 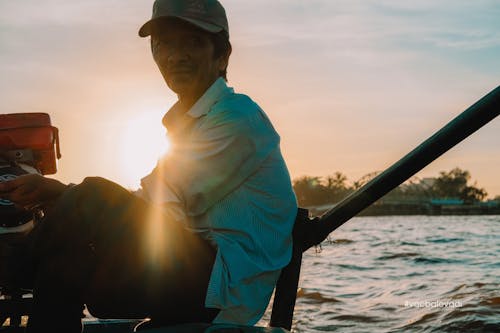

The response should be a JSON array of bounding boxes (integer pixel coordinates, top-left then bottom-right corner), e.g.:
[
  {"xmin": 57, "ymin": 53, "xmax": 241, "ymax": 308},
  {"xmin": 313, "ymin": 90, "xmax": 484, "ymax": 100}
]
[{"xmin": 260, "ymin": 216, "xmax": 500, "ymax": 333}]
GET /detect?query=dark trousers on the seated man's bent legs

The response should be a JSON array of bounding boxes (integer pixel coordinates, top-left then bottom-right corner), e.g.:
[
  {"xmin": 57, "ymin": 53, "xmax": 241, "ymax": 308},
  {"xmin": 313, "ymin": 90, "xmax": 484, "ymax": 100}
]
[{"xmin": 20, "ymin": 178, "xmax": 218, "ymax": 333}]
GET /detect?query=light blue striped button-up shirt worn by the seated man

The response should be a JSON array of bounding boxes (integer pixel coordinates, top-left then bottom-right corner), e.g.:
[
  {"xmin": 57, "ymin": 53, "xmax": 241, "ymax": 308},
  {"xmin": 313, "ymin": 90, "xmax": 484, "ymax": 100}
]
[{"xmin": 141, "ymin": 78, "xmax": 297, "ymax": 325}]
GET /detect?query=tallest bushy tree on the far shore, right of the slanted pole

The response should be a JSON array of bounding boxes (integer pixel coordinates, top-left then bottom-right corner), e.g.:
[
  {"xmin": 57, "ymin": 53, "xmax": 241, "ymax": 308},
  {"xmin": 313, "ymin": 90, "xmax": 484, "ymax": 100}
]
[{"xmin": 432, "ymin": 168, "xmax": 488, "ymax": 202}]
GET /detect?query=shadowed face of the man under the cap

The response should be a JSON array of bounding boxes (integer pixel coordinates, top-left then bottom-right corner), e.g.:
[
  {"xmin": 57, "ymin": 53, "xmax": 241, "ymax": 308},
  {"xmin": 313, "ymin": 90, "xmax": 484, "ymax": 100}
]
[{"xmin": 151, "ymin": 19, "xmax": 227, "ymax": 103}]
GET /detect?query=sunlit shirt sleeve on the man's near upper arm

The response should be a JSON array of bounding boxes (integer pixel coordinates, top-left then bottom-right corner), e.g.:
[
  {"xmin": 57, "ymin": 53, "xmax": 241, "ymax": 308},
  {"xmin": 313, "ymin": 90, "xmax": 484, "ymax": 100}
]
[{"xmin": 158, "ymin": 105, "xmax": 279, "ymax": 216}]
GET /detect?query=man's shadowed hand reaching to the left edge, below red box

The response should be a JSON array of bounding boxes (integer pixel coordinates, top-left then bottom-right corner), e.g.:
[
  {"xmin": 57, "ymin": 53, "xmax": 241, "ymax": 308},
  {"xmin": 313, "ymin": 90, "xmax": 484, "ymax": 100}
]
[{"xmin": 0, "ymin": 174, "xmax": 68, "ymax": 209}]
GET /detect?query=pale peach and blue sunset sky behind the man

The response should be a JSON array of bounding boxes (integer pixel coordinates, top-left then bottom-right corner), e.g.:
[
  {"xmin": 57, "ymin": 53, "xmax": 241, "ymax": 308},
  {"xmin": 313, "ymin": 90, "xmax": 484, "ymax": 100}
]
[{"xmin": 0, "ymin": 0, "xmax": 500, "ymax": 197}]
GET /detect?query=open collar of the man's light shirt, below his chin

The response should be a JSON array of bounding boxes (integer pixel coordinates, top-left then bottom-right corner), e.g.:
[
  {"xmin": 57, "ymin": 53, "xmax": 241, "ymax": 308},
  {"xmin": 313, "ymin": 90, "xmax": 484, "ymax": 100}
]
[{"xmin": 162, "ymin": 77, "xmax": 234, "ymax": 131}]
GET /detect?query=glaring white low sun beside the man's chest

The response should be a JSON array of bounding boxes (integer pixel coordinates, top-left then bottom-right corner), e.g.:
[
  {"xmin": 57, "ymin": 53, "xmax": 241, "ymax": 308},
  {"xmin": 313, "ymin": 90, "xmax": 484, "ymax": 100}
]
[{"xmin": 119, "ymin": 112, "xmax": 170, "ymax": 189}]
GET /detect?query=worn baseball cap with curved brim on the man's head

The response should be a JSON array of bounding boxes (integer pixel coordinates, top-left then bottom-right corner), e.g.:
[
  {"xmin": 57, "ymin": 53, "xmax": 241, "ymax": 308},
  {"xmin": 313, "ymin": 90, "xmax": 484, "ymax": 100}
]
[{"xmin": 139, "ymin": 0, "xmax": 229, "ymax": 37}]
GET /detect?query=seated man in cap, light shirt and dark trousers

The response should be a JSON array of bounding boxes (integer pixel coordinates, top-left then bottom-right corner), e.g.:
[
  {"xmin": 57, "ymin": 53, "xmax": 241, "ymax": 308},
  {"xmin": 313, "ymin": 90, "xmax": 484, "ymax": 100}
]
[{"xmin": 0, "ymin": 0, "xmax": 297, "ymax": 332}]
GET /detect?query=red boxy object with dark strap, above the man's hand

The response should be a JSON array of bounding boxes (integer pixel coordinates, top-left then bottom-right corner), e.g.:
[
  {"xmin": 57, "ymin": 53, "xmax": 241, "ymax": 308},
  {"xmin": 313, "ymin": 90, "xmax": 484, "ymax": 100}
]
[{"xmin": 0, "ymin": 113, "xmax": 61, "ymax": 175}]
